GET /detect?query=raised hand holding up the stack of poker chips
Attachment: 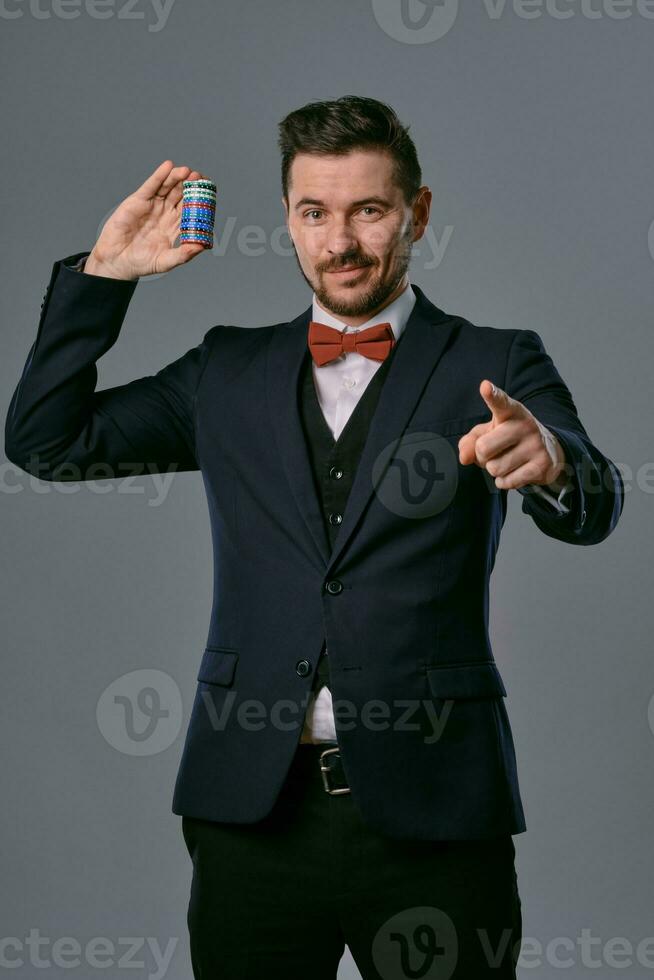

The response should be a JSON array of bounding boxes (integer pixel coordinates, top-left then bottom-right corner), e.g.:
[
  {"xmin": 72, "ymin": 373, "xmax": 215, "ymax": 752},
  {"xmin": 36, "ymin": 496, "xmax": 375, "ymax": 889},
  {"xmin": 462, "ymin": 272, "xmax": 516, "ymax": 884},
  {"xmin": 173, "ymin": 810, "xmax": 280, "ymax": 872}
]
[{"xmin": 84, "ymin": 160, "xmax": 213, "ymax": 280}]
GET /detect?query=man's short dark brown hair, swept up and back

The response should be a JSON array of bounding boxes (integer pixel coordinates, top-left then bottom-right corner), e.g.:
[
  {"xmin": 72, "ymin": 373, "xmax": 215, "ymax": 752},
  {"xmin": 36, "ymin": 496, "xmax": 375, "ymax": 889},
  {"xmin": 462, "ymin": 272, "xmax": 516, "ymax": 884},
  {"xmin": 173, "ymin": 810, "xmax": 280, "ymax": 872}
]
[{"xmin": 279, "ymin": 95, "xmax": 422, "ymax": 204}]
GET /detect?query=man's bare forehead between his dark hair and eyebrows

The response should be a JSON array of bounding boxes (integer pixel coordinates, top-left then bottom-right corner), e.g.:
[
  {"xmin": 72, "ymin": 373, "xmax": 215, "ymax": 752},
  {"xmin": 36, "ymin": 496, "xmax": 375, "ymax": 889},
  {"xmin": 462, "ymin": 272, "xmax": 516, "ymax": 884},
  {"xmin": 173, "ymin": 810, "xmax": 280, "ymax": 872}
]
[{"xmin": 289, "ymin": 150, "xmax": 401, "ymax": 205}]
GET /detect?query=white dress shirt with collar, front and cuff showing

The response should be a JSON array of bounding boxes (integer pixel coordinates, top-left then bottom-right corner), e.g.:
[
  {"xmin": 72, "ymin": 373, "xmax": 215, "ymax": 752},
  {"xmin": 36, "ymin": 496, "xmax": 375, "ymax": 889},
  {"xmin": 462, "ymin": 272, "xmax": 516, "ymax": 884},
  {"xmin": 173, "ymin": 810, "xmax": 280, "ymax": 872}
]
[{"xmin": 300, "ymin": 283, "xmax": 572, "ymax": 742}]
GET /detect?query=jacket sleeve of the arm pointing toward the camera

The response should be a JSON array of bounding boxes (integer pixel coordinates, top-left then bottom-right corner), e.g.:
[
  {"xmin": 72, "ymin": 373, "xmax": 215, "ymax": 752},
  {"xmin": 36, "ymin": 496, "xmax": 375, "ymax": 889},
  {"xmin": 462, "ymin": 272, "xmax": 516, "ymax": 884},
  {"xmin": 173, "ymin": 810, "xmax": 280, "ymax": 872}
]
[{"xmin": 504, "ymin": 330, "xmax": 624, "ymax": 545}]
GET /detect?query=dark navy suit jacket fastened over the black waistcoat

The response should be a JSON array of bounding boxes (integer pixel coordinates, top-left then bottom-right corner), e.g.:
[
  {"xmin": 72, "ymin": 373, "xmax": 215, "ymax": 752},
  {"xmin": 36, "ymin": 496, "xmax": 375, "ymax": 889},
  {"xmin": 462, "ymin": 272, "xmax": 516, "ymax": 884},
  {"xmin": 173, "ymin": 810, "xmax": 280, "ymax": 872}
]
[{"xmin": 5, "ymin": 252, "xmax": 624, "ymax": 839}]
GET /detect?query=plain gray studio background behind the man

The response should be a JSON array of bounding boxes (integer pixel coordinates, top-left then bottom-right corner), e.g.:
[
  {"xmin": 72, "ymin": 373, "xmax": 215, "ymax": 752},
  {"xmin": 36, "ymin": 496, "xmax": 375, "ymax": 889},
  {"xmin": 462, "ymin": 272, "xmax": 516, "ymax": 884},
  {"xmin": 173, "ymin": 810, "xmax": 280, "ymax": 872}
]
[{"xmin": 0, "ymin": 0, "xmax": 654, "ymax": 980}]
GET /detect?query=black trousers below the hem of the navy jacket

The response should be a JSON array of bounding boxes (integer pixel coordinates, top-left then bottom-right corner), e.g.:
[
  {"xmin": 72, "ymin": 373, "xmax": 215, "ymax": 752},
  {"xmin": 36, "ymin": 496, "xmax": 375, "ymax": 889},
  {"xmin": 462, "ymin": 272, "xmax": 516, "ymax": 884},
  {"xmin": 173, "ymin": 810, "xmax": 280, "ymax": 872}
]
[{"xmin": 182, "ymin": 745, "xmax": 522, "ymax": 980}]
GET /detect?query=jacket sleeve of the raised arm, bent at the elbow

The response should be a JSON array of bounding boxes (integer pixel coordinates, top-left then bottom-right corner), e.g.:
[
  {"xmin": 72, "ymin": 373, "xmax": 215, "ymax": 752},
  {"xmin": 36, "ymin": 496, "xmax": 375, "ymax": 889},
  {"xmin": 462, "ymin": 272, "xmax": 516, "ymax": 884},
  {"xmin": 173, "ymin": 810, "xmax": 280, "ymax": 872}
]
[{"xmin": 5, "ymin": 253, "xmax": 220, "ymax": 482}]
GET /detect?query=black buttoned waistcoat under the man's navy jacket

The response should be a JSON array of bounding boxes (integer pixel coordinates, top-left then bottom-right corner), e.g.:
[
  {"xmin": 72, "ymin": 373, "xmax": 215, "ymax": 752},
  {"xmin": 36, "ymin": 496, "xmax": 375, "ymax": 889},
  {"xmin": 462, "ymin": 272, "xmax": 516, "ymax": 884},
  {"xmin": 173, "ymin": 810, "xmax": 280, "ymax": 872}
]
[{"xmin": 299, "ymin": 334, "xmax": 403, "ymax": 692}]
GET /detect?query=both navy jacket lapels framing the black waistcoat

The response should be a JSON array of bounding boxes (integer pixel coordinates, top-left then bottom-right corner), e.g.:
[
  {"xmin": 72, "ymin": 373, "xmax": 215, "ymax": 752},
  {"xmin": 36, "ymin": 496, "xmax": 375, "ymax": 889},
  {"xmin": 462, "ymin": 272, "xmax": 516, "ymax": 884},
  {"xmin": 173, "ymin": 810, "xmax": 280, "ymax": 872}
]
[{"xmin": 266, "ymin": 283, "xmax": 456, "ymax": 573}]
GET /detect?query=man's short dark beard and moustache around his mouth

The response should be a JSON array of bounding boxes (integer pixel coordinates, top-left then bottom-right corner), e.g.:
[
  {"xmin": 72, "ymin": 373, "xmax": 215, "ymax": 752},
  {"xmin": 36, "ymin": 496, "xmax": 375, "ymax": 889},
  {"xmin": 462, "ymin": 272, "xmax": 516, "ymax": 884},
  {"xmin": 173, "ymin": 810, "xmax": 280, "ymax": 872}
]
[{"xmin": 293, "ymin": 226, "xmax": 413, "ymax": 317}]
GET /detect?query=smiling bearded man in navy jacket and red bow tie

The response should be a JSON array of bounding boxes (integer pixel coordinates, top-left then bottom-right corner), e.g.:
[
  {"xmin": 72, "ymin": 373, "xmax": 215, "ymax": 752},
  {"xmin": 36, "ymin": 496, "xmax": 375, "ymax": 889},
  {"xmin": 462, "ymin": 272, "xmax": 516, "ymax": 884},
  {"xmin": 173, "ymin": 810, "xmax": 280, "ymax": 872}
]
[{"xmin": 6, "ymin": 96, "xmax": 623, "ymax": 980}]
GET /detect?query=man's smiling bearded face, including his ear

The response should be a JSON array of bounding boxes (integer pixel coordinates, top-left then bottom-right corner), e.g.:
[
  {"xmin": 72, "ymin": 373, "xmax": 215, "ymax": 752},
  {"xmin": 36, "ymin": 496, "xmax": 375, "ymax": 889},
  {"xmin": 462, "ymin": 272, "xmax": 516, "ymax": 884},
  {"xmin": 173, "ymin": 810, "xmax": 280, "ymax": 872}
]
[{"xmin": 283, "ymin": 150, "xmax": 431, "ymax": 326}]
